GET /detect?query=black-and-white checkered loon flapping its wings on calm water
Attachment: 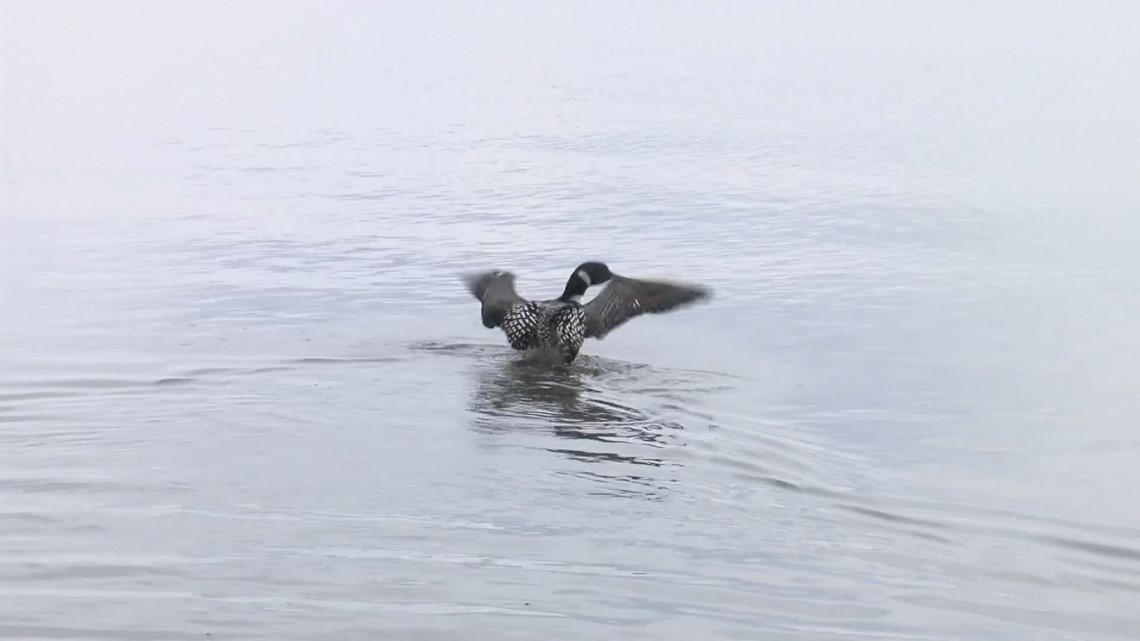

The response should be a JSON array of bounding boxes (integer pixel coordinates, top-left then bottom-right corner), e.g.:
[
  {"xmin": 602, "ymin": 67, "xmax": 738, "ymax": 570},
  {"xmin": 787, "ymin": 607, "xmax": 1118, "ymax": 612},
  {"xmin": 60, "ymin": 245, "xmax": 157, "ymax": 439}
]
[{"xmin": 464, "ymin": 261, "xmax": 711, "ymax": 365}]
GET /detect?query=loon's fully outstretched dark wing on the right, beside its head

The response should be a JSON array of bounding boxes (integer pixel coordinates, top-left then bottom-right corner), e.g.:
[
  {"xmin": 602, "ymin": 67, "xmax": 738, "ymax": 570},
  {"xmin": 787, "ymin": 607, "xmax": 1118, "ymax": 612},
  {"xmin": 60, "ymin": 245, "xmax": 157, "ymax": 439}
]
[{"xmin": 583, "ymin": 275, "xmax": 713, "ymax": 339}]
